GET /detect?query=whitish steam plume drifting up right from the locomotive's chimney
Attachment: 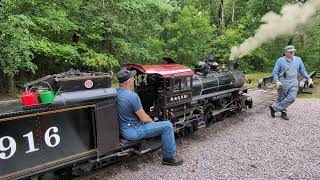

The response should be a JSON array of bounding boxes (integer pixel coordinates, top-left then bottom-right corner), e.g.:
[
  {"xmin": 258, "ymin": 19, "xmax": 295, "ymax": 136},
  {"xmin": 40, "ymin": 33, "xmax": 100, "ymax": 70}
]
[{"xmin": 229, "ymin": 0, "xmax": 320, "ymax": 60}]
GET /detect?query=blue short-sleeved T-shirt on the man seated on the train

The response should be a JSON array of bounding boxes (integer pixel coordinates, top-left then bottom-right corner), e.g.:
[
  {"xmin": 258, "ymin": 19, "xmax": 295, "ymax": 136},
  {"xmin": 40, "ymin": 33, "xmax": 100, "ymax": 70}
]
[{"xmin": 117, "ymin": 87, "xmax": 142, "ymax": 130}]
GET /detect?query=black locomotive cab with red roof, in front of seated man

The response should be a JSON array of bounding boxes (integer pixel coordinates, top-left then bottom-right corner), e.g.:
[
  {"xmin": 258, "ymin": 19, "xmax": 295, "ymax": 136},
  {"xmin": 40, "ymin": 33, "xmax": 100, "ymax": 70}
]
[{"xmin": 127, "ymin": 63, "xmax": 193, "ymax": 120}]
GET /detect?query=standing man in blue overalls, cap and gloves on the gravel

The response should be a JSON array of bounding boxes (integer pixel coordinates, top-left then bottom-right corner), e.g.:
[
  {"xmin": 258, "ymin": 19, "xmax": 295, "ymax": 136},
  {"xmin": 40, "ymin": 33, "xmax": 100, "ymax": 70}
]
[{"xmin": 270, "ymin": 45, "xmax": 313, "ymax": 120}]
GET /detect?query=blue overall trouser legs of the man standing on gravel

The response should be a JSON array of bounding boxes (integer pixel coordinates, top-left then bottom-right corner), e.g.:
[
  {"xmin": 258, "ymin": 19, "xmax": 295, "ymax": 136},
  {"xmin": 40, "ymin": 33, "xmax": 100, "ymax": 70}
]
[{"xmin": 272, "ymin": 79, "xmax": 299, "ymax": 112}]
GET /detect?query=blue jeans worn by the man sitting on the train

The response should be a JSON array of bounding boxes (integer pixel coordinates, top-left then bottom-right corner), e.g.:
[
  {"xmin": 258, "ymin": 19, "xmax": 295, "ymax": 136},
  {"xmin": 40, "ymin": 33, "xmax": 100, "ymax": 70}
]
[{"xmin": 121, "ymin": 121, "xmax": 176, "ymax": 158}]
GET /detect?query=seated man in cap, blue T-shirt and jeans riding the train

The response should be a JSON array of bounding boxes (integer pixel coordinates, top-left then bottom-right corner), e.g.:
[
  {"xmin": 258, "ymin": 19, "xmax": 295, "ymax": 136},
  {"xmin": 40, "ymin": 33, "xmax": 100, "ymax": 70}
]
[{"xmin": 117, "ymin": 68, "xmax": 183, "ymax": 166}]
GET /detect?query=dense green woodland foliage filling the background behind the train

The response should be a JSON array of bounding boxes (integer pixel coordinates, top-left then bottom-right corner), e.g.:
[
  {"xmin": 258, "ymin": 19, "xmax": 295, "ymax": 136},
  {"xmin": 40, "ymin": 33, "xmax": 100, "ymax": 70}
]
[{"xmin": 0, "ymin": 0, "xmax": 320, "ymax": 91}]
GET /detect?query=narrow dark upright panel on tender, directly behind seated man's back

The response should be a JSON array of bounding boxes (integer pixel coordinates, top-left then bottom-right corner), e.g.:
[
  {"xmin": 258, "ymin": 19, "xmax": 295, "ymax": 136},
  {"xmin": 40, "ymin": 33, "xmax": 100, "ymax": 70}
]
[{"xmin": 95, "ymin": 100, "xmax": 120, "ymax": 156}]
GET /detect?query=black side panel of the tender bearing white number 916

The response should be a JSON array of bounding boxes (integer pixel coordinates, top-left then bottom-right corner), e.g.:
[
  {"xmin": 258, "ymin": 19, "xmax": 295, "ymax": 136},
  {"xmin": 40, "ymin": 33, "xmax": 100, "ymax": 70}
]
[{"xmin": 0, "ymin": 107, "xmax": 93, "ymax": 179}]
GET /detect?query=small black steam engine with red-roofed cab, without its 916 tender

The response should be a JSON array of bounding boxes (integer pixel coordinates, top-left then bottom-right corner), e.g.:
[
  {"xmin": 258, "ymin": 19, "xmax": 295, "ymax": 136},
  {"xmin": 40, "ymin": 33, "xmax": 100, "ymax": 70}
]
[{"xmin": 126, "ymin": 61, "xmax": 250, "ymax": 133}]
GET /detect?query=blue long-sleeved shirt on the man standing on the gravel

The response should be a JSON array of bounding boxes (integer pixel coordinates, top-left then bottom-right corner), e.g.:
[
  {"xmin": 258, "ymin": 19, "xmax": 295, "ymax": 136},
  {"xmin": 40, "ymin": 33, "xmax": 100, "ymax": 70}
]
[{"xmin": 272, "ymin": 56, "xmax": 310, "ymax": 81}]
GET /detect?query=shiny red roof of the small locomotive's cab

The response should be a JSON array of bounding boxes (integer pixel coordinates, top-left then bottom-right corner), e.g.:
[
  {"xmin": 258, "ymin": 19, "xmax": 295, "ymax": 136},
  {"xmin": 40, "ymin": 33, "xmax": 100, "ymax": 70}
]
[{"xmin": 126, "ymin": 64, "xmax": 193, "ymax": 78}]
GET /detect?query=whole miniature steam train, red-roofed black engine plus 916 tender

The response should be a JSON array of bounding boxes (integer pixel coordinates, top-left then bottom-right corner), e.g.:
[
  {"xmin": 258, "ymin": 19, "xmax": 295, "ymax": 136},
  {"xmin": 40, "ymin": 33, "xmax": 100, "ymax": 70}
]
[{"xmin": 0, "ymin": 58, "xmax": 252, "ymax": 179}]
